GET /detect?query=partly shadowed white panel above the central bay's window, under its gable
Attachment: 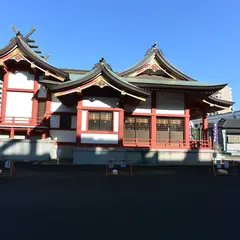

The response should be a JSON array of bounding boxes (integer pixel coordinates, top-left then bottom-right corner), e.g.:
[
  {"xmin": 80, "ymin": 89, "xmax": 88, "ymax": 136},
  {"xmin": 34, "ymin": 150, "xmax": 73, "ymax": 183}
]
[{"xmin": 83, "ymin": 97, "xmax": 119, "ymax": 108}]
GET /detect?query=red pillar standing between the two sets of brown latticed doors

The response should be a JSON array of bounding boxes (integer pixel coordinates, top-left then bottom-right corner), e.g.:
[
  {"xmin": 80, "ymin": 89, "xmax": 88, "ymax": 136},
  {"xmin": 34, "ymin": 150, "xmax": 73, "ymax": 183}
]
[{"xmin": 151, "ymin": 92, "xmax": 157, "ymax": 148}]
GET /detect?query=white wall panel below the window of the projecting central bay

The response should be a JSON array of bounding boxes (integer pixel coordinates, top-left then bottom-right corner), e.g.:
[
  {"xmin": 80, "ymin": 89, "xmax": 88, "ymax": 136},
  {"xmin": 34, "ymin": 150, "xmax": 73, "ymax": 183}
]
[{"xmin": 81, "ymin": 133, "xmax": 118, "ymax": 144}]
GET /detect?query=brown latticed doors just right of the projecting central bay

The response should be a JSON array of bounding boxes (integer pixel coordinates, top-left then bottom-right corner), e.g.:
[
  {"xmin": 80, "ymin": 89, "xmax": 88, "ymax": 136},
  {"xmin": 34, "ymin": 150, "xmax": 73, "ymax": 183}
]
[{"xmin": 124, "ymin": 117, "xmax": 150, "ymax": 140}]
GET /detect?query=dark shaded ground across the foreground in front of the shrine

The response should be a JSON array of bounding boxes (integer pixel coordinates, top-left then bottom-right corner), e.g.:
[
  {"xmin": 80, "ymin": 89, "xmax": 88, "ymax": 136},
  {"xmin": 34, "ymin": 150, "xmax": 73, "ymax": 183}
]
[{"xmin": 0, "ymin": 167, "xmax": 240, "ymax": 240}]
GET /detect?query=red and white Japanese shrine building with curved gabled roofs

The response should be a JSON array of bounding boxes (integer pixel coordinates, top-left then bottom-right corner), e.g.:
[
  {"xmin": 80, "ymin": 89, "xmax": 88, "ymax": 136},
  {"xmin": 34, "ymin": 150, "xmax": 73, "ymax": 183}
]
[{"xmin": 0, "ymin": 27, "xmax": 233, "ymax": 164}]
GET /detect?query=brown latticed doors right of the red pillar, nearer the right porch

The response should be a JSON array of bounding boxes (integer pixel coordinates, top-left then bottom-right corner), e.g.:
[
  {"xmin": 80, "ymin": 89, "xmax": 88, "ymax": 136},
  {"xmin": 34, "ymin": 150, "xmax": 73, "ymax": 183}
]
[{"xmin": 157, "ymin": 118, "xmax": 184, "ymax": 141}]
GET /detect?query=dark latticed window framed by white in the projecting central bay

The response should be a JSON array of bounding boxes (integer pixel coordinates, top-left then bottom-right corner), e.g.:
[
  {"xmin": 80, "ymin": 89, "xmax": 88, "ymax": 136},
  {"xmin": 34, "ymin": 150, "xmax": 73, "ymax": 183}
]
[{"xmin": 88, "ymin": 111, "xmax": 113, "ymax": 131}]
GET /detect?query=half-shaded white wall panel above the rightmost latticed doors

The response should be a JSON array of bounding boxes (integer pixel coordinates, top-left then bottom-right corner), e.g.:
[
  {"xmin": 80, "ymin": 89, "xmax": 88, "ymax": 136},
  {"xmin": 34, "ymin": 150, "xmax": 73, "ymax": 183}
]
[{"xmin": 156, "ymin": 92, "xmax": 184, "ymax": 114}]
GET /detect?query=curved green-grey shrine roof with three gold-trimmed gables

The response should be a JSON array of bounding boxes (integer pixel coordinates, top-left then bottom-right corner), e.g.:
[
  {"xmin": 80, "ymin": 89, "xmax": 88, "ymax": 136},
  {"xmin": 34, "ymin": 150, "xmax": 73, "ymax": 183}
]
[{"xmin": 0, "ymin": 27, "xmax": 234, "ymax": 108}]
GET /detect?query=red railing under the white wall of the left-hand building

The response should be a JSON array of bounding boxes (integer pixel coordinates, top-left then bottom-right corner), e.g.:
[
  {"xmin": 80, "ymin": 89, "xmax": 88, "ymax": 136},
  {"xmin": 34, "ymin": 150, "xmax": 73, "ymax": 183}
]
[{"xmin": 0, "ymin": 117, "xmax": 43, "ymax": 125}]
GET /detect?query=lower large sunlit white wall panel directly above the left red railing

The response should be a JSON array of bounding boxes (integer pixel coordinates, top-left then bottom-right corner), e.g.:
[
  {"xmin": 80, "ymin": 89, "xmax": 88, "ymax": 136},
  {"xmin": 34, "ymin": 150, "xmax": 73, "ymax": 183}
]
[{"xmin": 6, "ymin": 92, "xmax": 33, "ymax": 117}]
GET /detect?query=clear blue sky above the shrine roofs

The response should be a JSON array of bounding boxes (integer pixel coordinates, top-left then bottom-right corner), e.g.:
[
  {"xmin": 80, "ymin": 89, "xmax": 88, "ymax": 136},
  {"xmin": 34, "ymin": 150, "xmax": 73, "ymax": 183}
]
[{"xmin": 0, "ymin": 0, "xmax": 240, "ymax": 110}]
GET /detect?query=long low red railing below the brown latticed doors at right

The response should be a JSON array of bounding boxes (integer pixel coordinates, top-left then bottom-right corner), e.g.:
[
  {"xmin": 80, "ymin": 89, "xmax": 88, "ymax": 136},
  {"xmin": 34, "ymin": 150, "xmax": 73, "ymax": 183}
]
[{"xmin": 123, "ymin": 138, "xmax": 212, "ymax": 149}]
